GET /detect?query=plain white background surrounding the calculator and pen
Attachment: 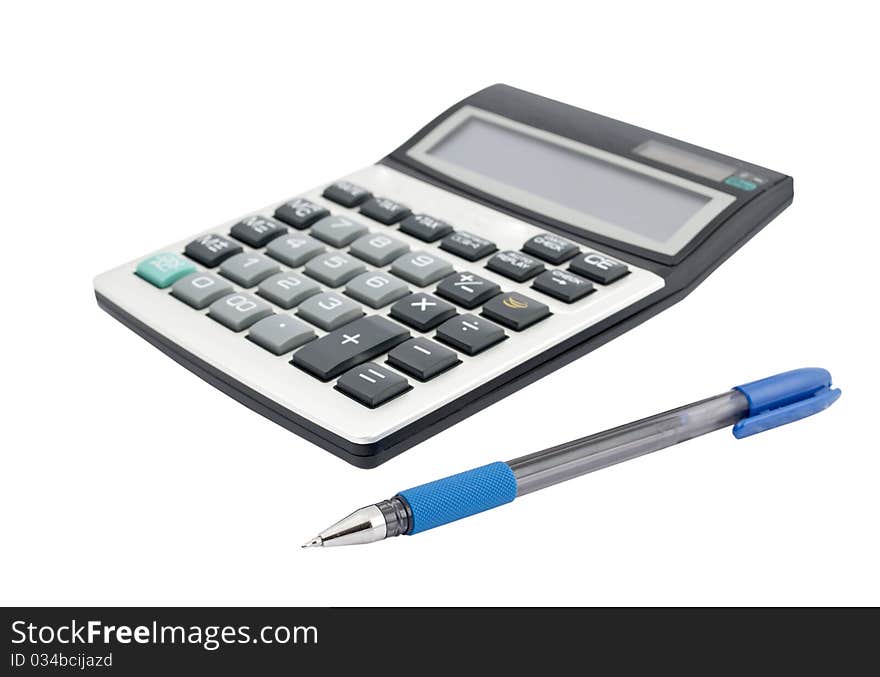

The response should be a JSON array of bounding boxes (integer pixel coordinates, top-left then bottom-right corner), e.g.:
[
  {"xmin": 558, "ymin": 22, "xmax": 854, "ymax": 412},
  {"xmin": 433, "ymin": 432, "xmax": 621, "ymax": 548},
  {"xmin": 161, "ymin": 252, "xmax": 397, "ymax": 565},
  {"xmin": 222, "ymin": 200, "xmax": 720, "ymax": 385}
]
[{"xmin": 0, "ymin": 0, "xmax": 880, "ymax": 605}]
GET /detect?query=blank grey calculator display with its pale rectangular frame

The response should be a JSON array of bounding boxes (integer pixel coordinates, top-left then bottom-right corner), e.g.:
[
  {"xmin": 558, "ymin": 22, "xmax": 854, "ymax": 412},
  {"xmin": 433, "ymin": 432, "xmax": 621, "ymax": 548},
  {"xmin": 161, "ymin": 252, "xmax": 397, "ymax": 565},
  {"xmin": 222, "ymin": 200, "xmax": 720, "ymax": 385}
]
[{"xmin": 415, "ymin": 109, "xmax": 733, "ymax": 254}]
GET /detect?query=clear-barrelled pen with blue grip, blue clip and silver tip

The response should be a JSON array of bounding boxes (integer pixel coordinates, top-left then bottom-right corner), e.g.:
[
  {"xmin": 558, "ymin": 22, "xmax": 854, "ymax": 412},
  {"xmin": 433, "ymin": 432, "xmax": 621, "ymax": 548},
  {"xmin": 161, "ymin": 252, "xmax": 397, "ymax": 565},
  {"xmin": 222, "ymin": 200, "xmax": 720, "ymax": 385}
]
[{"xmin": 303, "ymin": 368, "xmax": 840, "ymax": 548}]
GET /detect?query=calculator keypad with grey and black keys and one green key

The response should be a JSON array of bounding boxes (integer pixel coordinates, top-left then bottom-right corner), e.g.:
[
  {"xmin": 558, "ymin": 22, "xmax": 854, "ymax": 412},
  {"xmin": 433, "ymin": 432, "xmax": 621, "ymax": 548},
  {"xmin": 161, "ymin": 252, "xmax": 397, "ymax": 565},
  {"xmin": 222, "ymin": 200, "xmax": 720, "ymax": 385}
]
[{"xmin": 106, "ymin": 162, "xmax": 657, "ymax": 435}]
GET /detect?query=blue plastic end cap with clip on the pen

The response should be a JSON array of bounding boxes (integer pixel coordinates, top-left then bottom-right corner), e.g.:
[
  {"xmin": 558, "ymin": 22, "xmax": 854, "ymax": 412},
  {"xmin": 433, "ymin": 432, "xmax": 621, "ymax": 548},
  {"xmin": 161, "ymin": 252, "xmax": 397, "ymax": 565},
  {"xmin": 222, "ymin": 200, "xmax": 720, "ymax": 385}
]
[{"xmin": 733, "ymin": 368, "xmax": 840, "ymax": 439}]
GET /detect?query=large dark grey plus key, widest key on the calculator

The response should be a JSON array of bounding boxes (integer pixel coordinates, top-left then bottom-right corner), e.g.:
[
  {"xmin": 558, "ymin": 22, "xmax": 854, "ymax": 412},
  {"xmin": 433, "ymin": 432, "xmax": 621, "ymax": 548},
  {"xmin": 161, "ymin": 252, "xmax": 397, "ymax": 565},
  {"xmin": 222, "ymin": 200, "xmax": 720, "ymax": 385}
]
[{"xmin": 291, "ymin": 315, "xmax": 409, "ymax": 381}]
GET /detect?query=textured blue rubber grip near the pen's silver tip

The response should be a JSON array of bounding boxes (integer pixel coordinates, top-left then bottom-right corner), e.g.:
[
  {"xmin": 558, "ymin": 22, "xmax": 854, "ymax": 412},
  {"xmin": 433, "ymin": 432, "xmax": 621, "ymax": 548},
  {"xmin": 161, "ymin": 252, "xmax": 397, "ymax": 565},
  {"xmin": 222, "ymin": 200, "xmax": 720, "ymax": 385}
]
[{"xmin": 398, "ymin": 462, "xmax": 516, "ymax": 534}]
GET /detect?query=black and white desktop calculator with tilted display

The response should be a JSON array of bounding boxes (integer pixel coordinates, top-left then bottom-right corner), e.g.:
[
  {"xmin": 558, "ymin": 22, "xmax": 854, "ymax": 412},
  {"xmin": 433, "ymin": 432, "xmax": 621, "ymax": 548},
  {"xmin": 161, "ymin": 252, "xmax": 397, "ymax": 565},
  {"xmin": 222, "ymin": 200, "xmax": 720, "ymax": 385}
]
[{"xmin": 94, "ymin": 85, "xmax": 793, "ymax": 468}]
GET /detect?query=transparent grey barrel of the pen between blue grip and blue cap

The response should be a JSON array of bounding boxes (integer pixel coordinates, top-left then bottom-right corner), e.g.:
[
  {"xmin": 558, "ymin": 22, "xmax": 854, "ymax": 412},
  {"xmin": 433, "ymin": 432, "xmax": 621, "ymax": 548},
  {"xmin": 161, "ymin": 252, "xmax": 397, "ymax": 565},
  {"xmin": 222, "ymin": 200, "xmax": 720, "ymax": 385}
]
[{"xmin": 507, "ymin": 390, "xmax": 749, "ymax": 496}]
